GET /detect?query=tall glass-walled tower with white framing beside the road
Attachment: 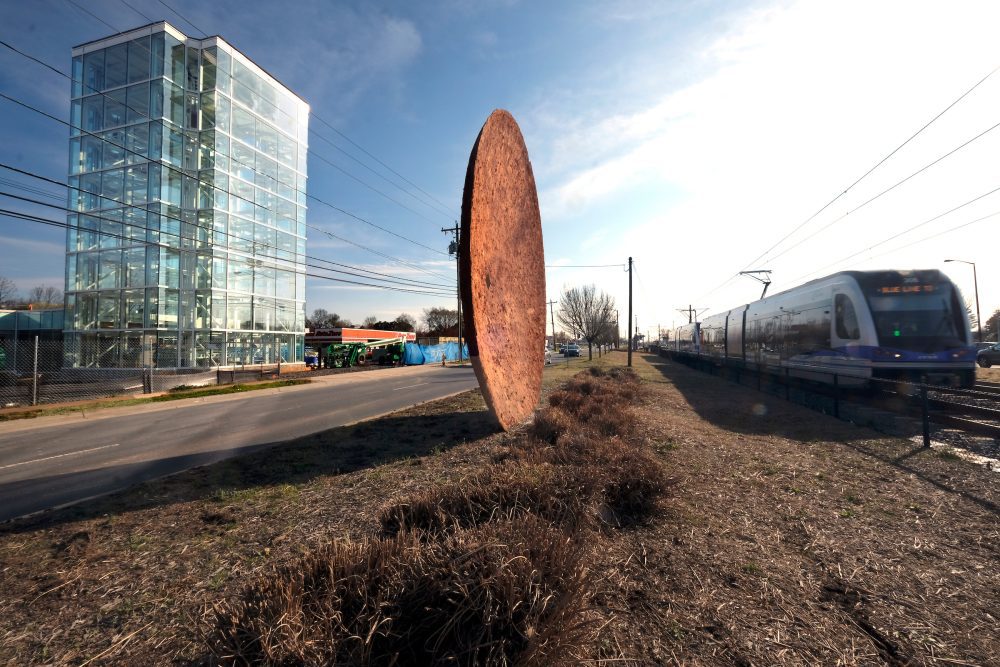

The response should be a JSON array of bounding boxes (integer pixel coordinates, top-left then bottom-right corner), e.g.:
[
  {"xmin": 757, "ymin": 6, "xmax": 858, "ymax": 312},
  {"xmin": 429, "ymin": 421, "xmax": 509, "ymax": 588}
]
[{"xmin": 64, "ymin": 22, "xmax": 309, "ymax": 368}]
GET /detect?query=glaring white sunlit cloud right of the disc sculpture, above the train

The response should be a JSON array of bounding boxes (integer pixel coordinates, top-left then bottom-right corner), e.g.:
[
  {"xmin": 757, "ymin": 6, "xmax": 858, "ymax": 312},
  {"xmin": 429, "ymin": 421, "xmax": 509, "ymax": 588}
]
[{"xmin": 525, "ymin": 2, "xmax": 1000, "ymax": 328}]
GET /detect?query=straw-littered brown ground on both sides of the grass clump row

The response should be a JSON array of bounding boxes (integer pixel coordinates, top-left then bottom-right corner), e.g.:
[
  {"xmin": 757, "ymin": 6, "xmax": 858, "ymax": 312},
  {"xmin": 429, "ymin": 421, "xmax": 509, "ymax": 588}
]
[{"xmin": 0, "ymin": 353, "xmax": 1000, "ymax": 665}]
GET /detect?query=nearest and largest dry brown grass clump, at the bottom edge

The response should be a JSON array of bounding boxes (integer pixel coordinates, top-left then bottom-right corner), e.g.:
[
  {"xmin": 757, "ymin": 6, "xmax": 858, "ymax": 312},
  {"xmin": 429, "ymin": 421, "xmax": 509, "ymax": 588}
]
[{"xmin": 211, "ymin": 520, "xmax": 589, "ymax": 665}]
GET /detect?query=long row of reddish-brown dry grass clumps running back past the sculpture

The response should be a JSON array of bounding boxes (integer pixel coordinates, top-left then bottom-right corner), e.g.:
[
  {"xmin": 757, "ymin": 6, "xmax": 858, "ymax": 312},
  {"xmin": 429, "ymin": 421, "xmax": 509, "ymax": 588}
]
[{"xmin": 211, "ymin": 369, "xmax": 665, "ymax": 665}]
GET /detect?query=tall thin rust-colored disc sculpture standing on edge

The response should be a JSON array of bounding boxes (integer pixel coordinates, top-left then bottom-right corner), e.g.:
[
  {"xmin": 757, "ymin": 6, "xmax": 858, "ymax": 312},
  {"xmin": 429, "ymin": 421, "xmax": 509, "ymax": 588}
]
[{"xmin": 459, "ymin": 109, "xmax": 545, "ymax": 430}]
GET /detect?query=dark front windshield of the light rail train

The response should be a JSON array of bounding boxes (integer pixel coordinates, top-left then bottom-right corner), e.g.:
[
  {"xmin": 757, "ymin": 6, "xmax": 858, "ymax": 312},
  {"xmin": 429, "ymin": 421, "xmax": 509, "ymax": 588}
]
[{"xmin": 868, "ymin": 283, "xmax": 966, "ymax": 352}]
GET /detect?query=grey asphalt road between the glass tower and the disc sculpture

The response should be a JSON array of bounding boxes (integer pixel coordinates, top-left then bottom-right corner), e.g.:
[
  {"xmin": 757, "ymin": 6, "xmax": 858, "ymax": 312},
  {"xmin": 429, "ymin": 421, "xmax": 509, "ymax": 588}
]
[{"xmin": 0, "ymin": 366, "xmax": 477, "ymax": 521}]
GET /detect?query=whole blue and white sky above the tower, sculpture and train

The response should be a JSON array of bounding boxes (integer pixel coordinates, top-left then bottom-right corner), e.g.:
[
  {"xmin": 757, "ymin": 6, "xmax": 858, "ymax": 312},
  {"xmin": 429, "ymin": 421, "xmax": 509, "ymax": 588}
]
[{"xmin": 0, "ymin": 0, "xmax": 1000, "ymax": 336}]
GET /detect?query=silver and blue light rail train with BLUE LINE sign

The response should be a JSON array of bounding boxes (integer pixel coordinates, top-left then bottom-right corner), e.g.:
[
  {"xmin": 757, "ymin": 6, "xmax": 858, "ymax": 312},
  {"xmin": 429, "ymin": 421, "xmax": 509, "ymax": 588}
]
[{"xmin": 667, "ymin": 270, "xmax": 976, "ymax": 387}]
